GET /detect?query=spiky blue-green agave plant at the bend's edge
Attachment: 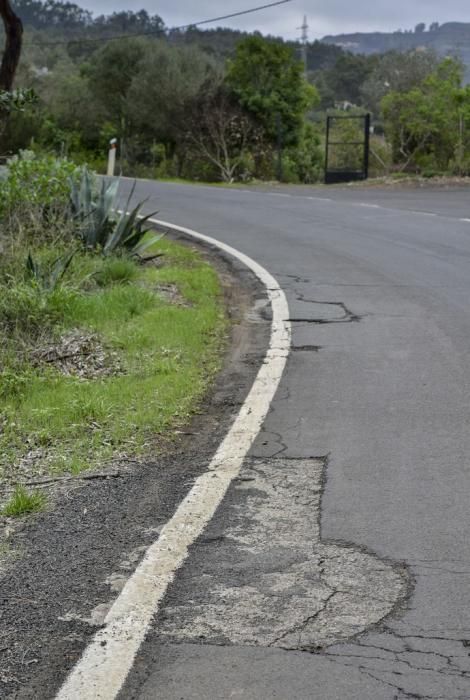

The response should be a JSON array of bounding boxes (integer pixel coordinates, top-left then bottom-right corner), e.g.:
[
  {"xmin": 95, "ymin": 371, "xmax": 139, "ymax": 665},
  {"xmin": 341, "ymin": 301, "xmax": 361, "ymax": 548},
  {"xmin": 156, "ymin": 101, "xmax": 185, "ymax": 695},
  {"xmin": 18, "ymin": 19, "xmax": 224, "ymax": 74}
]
[{"xmin": 70, "ymin": 168, "xmax": 162, "ymax": 258}]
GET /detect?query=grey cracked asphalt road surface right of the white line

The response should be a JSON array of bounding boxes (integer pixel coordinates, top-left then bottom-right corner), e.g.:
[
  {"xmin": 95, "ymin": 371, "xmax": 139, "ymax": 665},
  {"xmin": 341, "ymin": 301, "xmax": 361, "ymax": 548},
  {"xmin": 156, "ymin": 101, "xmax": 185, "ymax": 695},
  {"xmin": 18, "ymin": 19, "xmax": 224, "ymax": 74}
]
[{"xmin": 112, "ymin": 182, "xmax": 470, "ymax": 700}]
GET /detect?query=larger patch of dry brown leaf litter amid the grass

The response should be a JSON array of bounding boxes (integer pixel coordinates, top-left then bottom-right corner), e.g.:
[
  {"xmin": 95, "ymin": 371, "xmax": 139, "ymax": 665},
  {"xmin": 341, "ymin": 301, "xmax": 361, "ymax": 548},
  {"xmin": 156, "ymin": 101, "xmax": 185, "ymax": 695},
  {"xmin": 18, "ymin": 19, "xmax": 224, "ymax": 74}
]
[{"xmin": 31, "ymin": 329, "xmax": 123, "ymax": 379}]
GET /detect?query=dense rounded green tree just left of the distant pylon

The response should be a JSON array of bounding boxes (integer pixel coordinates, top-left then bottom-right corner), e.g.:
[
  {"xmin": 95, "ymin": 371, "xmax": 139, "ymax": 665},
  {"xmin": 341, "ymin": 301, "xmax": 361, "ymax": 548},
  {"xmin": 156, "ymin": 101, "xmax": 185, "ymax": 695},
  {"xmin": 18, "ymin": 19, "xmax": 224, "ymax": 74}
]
[{"xmin": 227, "ymin": 35, "xmax": 318, "ymax": 145}]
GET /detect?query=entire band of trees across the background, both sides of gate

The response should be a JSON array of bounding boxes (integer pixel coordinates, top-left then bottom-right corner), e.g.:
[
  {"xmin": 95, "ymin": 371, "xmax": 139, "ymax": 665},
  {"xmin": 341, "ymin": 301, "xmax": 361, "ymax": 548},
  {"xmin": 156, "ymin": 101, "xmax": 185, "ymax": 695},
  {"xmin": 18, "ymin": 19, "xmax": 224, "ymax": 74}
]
[{"xmin": 4, "ymin": 0, "xmax": 470, "ymax": 183}]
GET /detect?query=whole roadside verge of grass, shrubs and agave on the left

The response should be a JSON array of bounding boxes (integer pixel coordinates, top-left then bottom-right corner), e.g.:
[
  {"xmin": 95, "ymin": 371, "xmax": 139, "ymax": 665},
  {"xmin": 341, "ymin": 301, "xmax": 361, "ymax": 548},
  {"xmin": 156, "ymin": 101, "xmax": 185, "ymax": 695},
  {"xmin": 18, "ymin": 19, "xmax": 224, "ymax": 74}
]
[{"xmin": 0, "ymin": 154, "xmax": 225, "ymax": 516}]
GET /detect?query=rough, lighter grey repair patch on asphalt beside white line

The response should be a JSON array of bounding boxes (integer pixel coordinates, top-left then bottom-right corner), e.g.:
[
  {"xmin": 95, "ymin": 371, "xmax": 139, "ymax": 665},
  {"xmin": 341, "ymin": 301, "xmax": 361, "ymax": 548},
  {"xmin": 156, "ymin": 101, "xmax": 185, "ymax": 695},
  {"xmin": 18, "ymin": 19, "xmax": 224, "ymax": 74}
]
[{"xmin": 142, "ymin": 457, "xmax": 411, "ymax": 651}]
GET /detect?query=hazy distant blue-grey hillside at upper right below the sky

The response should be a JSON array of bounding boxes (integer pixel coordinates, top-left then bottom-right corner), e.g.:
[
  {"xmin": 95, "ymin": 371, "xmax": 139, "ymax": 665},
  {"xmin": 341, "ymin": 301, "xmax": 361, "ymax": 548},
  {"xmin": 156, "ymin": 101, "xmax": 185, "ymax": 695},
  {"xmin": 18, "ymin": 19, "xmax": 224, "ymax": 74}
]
[{"xmin": 321, "ymin": 22, "xmax": 470, "ymax": 80}]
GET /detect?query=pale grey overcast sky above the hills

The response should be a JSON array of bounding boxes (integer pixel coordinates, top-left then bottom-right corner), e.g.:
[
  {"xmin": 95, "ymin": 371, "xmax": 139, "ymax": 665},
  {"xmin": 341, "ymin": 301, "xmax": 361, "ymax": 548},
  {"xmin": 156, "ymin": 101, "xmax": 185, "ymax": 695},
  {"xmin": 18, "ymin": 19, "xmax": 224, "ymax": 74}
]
[{"xmin": 76, "ymin": 0, "xmax": 470, "ymax": 39}]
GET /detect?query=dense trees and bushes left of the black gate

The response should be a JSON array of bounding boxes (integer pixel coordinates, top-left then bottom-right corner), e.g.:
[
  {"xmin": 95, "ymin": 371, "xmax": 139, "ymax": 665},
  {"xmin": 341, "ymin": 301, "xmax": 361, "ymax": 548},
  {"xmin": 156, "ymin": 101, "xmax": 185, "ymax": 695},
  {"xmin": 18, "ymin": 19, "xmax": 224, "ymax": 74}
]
[{"xmin": 10, "ymin": 23, "xmax": 321, "ymax": 182}]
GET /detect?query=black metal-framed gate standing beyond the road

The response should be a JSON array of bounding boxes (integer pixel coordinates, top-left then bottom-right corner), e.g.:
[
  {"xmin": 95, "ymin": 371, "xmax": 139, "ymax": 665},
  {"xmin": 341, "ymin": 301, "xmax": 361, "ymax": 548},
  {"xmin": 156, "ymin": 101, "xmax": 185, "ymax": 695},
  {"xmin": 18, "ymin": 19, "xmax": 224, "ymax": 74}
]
[{"xmin": 325, "ymin": 114, "xmax": 370, "ymax": 185}]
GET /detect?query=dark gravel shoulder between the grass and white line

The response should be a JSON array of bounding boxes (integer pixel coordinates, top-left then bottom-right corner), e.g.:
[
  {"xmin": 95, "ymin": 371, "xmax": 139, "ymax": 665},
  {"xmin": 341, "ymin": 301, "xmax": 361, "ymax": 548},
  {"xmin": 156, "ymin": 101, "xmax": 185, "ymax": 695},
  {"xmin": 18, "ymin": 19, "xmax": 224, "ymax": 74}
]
[{"xmin": 1, "ymin": 231, "xmax": 271, "ymax": 698}]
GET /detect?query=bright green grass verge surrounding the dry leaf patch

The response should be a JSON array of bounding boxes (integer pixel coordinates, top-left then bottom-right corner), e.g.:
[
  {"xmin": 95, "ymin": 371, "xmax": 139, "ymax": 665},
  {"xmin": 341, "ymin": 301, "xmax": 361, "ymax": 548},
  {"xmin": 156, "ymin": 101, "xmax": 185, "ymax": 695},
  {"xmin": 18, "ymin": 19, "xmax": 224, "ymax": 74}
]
[{"xmin": 0, "ymin": 239, "xmax": 226, "ymax": 480}]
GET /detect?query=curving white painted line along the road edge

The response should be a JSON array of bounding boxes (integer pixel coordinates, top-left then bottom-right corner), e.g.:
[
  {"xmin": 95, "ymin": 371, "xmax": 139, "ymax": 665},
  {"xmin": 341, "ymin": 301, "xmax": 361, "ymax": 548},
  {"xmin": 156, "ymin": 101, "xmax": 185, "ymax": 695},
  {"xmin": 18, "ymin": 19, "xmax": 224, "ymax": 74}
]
[{"xmin": 56, "ymin": 220, "xmax": 291, "ymax": 700}]
